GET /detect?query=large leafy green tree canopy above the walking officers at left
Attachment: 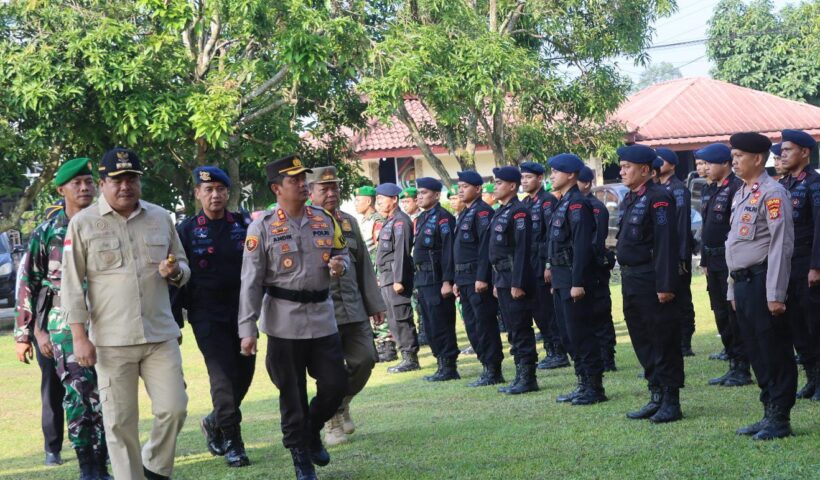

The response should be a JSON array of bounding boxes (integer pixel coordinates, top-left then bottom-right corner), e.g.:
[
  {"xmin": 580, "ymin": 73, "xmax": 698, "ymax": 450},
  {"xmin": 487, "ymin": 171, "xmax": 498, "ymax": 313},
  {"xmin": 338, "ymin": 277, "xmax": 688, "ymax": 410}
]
[{"xmin": 0, "ymin": 0, "xmax": 367, "ymax": 226}]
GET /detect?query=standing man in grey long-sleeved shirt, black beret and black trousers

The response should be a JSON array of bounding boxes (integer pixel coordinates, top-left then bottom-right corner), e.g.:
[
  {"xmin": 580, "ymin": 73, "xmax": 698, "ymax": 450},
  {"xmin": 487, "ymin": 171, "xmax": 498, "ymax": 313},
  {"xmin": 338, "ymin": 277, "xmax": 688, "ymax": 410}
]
[{"xmin": 726, "ymin": 133, "xmax": 797, "ymax": 440}]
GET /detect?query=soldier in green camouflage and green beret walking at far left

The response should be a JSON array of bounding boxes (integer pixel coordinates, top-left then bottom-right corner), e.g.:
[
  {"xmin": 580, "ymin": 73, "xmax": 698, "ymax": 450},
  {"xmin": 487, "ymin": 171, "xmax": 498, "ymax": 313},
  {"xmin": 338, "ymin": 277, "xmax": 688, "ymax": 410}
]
[{"xmin": 17, "ymin": 158, "xmax": 111, "ymax": 480}]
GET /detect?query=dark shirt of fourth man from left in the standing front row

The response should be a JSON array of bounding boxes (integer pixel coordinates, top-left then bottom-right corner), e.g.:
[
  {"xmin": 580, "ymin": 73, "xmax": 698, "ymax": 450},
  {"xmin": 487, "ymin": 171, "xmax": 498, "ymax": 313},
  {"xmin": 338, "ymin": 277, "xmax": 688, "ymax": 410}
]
[{"xmin": 478, "ymin": 196, "xmax": 533, "ymax": 294}]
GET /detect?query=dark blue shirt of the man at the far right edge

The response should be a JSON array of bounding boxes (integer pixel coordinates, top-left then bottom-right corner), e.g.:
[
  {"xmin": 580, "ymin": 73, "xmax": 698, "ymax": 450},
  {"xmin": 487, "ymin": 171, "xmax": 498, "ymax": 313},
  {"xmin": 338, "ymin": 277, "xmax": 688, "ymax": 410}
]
[{"xmin": 780, "ymin": 166, "xmax": 820, "ymax": 268}]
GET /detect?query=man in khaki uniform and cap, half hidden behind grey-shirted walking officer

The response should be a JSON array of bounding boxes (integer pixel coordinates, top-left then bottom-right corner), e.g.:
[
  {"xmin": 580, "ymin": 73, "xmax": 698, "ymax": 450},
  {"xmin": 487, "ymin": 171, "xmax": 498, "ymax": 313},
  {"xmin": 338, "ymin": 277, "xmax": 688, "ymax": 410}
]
[{"xmin": 308, "ymin": 167, "xmax": 385, "ymax": 445}]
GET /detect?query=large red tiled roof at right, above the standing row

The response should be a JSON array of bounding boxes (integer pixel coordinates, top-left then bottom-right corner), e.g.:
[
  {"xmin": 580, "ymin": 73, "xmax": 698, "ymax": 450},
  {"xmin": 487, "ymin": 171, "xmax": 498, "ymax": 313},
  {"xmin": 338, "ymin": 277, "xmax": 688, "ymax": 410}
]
[{"xmin": 613, "ymin": 78, "xmax": 820, "ymax": 150}]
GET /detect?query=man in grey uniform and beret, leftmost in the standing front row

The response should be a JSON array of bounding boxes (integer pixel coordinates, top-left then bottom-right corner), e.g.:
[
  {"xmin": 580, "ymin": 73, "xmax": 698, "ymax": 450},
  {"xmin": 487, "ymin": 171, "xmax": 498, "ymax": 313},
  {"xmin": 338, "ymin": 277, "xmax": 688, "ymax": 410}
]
[{"xmin": 376, "ymin": 183, "xmax": 420, "ymax": 373}]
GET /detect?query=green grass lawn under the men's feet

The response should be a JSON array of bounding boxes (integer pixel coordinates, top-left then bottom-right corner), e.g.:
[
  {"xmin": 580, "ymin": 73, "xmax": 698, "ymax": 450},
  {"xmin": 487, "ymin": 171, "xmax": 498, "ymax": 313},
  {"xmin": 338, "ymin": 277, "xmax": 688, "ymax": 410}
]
[{"xmin": 0, "ymin": 276, "xmax": 820, "ymax": 480}]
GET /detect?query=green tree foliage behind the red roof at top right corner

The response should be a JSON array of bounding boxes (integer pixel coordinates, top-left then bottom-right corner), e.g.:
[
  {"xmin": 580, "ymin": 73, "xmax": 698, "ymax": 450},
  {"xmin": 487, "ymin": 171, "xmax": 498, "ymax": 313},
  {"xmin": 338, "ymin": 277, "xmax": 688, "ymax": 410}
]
[{"xmin": 706, "ymin": 0, "xmax": 820, "ymax": 105}]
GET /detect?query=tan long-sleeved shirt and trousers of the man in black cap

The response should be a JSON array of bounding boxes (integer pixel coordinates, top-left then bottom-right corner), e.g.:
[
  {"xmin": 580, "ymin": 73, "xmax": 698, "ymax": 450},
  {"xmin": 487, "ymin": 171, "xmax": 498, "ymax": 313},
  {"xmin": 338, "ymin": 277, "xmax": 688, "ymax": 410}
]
[{"xmin": 60, "ymin": 149, "xmax": 190, "ymax": 479}]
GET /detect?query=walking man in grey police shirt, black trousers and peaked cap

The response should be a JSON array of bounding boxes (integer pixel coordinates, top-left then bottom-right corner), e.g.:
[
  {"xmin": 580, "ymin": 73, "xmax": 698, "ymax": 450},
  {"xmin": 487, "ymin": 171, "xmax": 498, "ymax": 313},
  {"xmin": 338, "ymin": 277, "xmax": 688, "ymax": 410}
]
[{"xmin": 239, "ymin": 155, "xmax": 349, "ymax": 480}]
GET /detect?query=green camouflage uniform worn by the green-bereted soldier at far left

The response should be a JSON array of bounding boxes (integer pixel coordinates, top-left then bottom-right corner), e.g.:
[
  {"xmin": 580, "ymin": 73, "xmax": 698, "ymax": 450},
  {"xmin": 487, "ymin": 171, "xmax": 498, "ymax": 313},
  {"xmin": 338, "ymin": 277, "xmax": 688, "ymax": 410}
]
[{"xmin": 14, "ymin": 210, "xmax": 105, "ymax": 449}]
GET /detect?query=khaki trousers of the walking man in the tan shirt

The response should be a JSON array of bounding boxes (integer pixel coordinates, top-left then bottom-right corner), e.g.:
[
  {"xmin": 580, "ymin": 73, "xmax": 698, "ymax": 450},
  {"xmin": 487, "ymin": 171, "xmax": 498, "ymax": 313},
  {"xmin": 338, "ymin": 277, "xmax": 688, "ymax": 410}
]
[{"xmin": 96, "ymin": 339, "xmax": 188, "ymax": 480}]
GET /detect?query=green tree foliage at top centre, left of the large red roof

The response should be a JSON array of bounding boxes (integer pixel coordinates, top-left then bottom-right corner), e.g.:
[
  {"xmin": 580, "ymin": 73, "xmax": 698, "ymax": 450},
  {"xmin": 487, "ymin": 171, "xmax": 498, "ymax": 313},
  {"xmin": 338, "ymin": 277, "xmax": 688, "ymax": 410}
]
[{"xmin": 360, "ymin": 0, "xmax": 675, "ymax": 182}]
